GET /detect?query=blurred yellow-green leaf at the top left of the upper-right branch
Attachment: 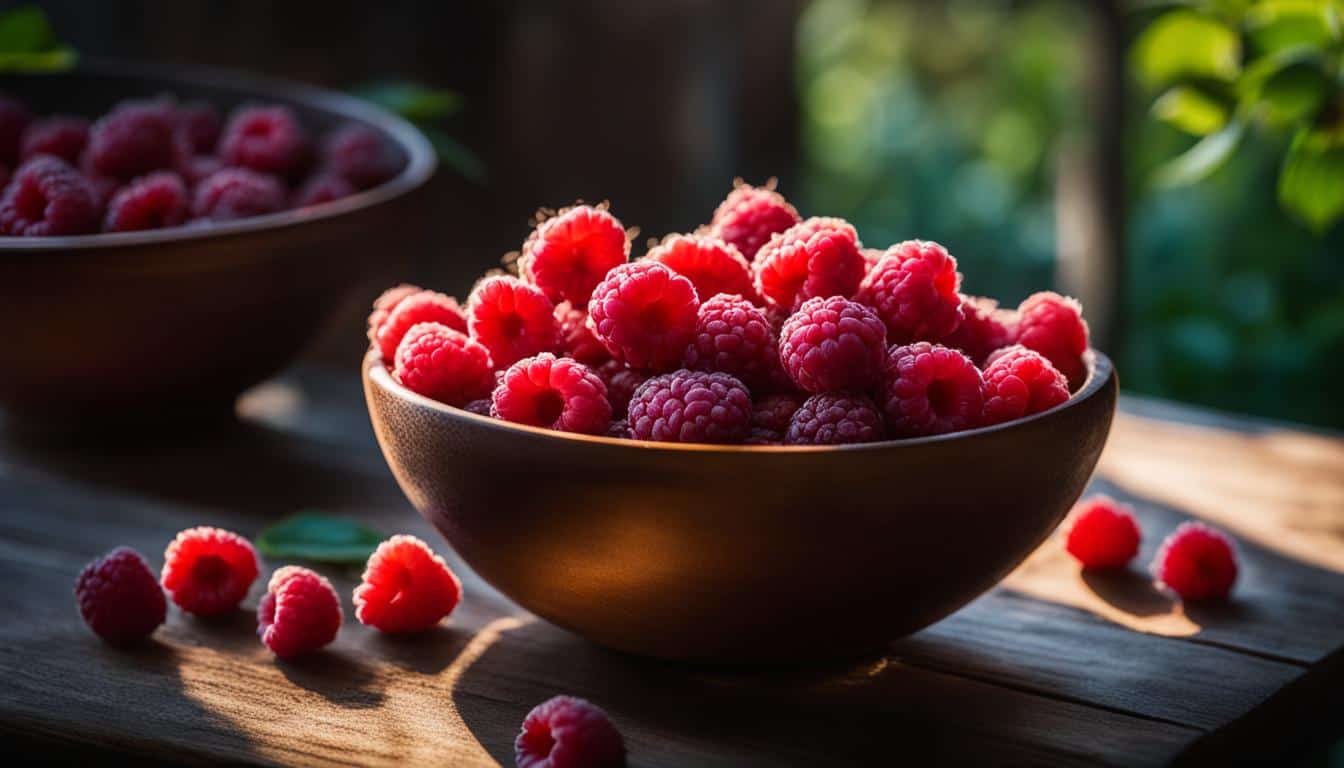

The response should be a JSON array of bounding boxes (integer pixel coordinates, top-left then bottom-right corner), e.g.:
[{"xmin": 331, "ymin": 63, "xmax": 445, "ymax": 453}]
[{"xmin": 1130, "ymin": 9, "xmax": 1242, "ymax": 87}]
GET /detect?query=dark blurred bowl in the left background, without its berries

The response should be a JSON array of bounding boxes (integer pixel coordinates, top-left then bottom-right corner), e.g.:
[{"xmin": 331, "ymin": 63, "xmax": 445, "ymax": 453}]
[{"xmin": 0, "ymin": 63, "xmax": 435, "ymax": 424}]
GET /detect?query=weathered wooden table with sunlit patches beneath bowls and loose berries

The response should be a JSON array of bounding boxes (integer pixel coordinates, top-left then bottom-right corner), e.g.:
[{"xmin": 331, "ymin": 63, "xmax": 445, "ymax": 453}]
[{"xmin": 0, "ymin": 371, "xmax": 1344, "ymax": 765}]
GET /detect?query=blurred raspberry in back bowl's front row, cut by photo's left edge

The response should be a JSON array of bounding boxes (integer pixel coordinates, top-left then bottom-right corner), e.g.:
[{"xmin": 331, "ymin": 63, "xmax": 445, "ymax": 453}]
[{"xmin": 0, "ymin": 155, "xmax": 99, "ymax": 237}]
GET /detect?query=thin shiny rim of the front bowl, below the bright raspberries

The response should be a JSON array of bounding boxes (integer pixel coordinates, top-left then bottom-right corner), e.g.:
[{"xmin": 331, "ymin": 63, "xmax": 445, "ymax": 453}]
[{"xmin": 363, "ymin": 347, "xmax": 1116, "ymax": 453}]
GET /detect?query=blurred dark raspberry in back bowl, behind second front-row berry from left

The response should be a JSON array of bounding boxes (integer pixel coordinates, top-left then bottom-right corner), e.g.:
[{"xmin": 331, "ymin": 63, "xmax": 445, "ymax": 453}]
[{"xmin": 89, "ymin": 102, "xmax": 176, "ymax": 179}]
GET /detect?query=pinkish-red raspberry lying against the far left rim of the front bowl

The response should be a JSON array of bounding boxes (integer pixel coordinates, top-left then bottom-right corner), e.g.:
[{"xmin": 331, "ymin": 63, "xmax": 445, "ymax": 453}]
[{"xmin": 392, "ymin": 321, "xmax": 495, "ymax": 406}]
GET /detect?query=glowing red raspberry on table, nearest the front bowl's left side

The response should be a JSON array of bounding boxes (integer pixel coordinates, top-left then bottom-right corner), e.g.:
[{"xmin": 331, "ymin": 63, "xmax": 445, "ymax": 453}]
[{"xmin": 355, "ymin": 535, "xmax": 462, "ymax": 633}]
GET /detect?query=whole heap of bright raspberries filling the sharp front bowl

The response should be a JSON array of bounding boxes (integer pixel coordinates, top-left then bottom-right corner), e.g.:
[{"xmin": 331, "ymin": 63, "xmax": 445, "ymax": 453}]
[{"xmin": 368, "ymin": 182, "xmax": 1087, "ymax": 445}]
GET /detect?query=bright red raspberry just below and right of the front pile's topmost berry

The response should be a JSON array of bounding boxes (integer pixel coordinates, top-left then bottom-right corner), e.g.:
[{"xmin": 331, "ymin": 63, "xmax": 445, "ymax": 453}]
[{"xmin": 751, "ymin": 218, "xmax": 864, "ymax": 309}]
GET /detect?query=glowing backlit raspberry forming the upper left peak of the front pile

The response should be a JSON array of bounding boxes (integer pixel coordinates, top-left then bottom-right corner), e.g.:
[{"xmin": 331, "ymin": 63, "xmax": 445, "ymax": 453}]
[{"xmin": 517, "ymin": 206, "xmax": 630, "ymax": 307}]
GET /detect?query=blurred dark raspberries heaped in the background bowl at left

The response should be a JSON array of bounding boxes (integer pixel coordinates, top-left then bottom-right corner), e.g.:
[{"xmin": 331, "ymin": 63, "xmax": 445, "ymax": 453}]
[{"xmin": 0, "ymin": 90, "xmax": 405, "ymax": 237}]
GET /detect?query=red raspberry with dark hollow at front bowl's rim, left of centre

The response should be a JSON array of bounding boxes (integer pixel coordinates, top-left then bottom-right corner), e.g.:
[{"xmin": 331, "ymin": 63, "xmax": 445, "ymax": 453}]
[{"xmin": 492, "ymin": 352, "xmax": 612, "ymax": 434}]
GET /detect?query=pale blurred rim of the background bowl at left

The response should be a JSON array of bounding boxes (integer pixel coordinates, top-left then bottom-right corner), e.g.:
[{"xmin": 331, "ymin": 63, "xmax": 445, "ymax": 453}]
[{"xmin": 0, "ymin": 58, "xmax": 438, "ymax": 254}]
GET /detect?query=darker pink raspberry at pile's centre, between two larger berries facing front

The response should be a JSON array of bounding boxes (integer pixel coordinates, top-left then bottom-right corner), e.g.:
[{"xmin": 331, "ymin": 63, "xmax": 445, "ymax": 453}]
[{"xmin": 681, "ymin": 293, "xmax": 781, "ymax": 391}]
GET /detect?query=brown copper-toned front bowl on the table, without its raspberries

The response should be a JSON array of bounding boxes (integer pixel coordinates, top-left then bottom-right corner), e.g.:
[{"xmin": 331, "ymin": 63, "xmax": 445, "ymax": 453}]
[{"xmin": 363, "ymin": 352, "xmax": 1117, "ymax": 663}]
